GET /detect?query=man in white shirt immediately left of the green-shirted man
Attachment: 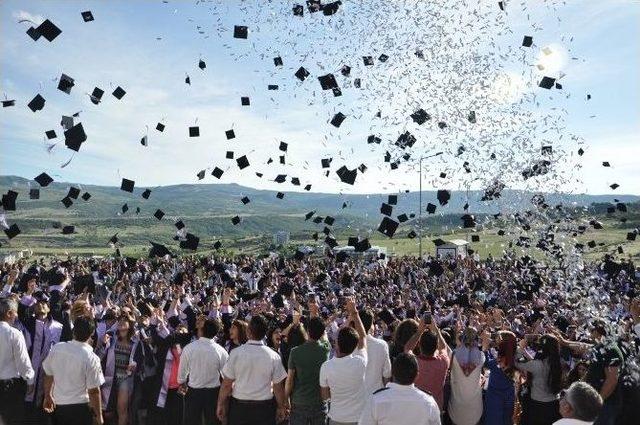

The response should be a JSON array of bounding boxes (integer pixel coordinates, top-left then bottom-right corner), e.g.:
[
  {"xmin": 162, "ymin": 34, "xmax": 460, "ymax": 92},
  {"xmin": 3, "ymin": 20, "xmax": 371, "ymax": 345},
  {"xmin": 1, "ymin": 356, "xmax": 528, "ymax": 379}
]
[{"xmin": 217, "ymin": 315, "xmax": 287, "ymax": 425}]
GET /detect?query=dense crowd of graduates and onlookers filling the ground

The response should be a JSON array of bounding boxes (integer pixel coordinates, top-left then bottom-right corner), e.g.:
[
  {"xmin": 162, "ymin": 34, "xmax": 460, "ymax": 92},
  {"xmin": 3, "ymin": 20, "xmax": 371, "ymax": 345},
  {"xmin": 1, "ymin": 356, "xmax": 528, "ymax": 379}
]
[{"xmin": 0, "ymin": 254, "xmax": 640, "ymax": 425}]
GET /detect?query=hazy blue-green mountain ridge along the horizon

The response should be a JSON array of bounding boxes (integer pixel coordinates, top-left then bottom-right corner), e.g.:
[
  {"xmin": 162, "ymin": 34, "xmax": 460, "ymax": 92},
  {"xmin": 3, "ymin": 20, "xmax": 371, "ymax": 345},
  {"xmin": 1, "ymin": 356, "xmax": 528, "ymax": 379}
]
[{"xmin": 0, "ymin": 176, "xmax": 640, "ymax": 222}]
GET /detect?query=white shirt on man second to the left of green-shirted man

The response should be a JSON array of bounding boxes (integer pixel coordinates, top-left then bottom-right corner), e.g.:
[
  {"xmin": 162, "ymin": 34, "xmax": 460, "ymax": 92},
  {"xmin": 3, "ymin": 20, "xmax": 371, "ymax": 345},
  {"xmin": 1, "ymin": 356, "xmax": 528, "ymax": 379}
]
[{"xmin": 178, "ymin": 337, "xmax": 229, "ymax": 388}]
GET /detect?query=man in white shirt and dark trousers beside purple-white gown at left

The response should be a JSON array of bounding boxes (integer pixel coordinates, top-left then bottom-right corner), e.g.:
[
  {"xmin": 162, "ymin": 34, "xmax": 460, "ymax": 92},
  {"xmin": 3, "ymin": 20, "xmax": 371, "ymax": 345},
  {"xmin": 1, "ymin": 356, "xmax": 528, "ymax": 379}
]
[{"xmin": 42, "ymin": 316, "xmax": 104, "ymax": 425}]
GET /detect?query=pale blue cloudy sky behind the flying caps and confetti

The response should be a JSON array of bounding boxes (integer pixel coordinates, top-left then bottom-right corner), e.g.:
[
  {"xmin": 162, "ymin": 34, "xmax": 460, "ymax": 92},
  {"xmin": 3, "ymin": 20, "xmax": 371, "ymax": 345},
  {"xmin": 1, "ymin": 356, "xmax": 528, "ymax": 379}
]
[{"xmin": 0, "ymin": 0, "xmax": 640, "ymax": 194}]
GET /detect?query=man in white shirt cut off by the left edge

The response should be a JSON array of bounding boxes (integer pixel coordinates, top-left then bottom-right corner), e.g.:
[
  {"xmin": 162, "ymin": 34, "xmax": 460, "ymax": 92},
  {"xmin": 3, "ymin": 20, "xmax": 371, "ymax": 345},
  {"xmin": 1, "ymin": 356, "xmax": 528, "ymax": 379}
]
[{"xmin": 0, "ymin": 298, "xmax": 35, "ymax": 424}]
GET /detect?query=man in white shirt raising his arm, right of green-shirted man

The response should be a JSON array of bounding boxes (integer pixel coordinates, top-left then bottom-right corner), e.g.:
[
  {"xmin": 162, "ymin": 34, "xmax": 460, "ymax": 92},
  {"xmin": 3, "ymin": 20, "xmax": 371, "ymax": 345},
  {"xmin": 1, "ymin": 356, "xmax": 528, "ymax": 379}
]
[{"xmin": 320, "ymin": 299, "xmax": 367, "ymax": 425}]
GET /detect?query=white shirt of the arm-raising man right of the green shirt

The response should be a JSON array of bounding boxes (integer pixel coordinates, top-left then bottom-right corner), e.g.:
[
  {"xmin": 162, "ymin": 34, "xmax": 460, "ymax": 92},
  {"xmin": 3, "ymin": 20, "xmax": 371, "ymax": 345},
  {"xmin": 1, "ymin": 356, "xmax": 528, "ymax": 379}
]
[{"xmin": 320, "ymin": 349, "xmax": 367, "ymax": 422}]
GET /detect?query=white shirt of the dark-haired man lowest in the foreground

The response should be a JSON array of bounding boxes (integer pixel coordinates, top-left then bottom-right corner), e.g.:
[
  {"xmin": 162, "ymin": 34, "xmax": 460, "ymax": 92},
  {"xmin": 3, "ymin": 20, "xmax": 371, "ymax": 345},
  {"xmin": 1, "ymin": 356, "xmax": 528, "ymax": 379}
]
[{"xmin": 358, "ymin": 383, "xmax": 440, "ymax": 425}]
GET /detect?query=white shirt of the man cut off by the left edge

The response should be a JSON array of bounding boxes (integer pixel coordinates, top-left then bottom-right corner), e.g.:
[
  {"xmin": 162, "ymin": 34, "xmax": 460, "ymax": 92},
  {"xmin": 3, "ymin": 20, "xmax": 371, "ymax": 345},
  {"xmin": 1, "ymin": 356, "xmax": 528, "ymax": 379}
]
[{"xmin": 0, "ymin": 320, "xmax": 35, "ymax": 385}]
